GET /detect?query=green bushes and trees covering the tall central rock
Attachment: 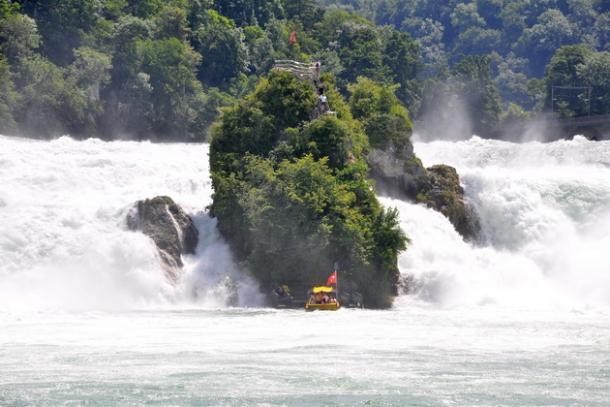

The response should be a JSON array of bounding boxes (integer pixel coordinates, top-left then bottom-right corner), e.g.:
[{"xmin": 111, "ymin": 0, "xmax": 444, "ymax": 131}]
[{"xmin": 210, "ymin": 72, "xmax": 405, "ymax": 307}]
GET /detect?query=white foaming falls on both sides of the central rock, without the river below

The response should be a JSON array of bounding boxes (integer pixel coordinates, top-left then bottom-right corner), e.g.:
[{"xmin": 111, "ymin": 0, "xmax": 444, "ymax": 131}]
[{"xmin": 0, "ymin": 136, "xmax": 610, "ymax": 310}]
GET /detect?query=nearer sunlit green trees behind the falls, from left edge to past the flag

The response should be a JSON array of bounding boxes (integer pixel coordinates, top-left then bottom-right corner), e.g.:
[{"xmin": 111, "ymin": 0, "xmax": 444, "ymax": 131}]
[{"xmin": 0, "ymin": 0, "xmax": 417, "ymax": 140}]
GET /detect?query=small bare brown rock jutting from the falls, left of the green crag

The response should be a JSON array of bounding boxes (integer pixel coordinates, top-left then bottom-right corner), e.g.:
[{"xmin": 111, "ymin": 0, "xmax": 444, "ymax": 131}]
[{"xmin": 127, "ymin": 196, "xmax": 199, "ymax": 280}]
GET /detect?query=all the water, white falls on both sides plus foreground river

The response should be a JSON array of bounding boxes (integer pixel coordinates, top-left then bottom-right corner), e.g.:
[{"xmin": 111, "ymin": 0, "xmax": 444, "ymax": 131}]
[{"xmin": 0, "ymin": 136, "xmax": 610, "ymax": 406}]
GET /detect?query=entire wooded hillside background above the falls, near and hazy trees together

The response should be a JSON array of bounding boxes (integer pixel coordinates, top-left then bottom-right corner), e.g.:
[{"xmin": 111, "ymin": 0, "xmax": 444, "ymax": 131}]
[{"xmin": 0, "ymin": 0, "xmax": 610, "ymax": 140}]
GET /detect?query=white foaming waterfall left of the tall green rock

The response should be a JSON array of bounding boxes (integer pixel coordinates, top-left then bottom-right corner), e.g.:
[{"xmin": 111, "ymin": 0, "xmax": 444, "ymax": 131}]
[{"xmin": 0, "ymin": 136, "xmax": 256, "ymax": 311}]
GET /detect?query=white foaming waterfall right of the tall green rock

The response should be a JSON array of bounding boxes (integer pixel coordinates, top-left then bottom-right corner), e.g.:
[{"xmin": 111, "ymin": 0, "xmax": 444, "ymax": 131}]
[{"xmin": 384, "ymin": 137, "xmax": 610, "ymax": 309}]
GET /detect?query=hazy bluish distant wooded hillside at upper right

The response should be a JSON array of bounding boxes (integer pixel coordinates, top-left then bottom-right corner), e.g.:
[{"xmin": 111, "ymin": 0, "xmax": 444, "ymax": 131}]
[{"xmin": 321, "ymin": 0, "xmax": 610, "ymax": 121}]
